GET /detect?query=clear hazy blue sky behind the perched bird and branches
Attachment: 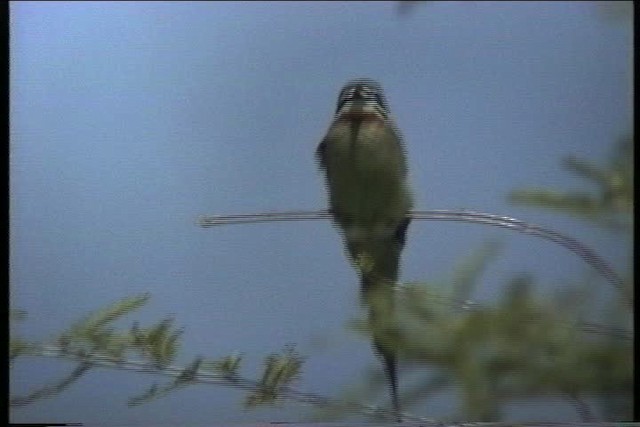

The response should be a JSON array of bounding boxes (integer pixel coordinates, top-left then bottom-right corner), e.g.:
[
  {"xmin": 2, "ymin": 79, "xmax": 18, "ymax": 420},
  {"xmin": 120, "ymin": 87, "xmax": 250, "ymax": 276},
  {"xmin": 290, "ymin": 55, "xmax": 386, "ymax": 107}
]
[{"xmin": 10, "ymin": 2, "xmax": 632, "ymax": 426}]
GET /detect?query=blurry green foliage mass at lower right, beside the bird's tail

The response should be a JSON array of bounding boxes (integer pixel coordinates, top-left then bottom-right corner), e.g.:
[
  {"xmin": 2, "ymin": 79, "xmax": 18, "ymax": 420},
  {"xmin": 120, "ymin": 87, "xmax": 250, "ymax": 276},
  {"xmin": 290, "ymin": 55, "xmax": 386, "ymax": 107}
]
[{"xmin": 322, "ymin": 242, "xmax": 633, "ymax": 421}]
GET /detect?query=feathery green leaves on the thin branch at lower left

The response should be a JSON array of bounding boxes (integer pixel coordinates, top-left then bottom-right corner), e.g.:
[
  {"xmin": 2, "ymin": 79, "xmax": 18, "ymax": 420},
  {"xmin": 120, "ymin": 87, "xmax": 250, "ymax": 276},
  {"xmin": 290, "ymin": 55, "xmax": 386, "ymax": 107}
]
[{"xmin": 10, "ymin": 294, "xmax": 304, "ymax": 412}]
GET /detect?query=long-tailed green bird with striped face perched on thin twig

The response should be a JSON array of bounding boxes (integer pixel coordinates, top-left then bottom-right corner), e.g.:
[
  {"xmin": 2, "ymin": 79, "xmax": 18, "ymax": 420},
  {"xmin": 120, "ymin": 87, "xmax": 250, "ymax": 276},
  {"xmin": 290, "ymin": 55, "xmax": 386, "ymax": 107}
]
[{"xmin": 316, "ymin": 78, "xmax": 413, "ymax": 422}]
